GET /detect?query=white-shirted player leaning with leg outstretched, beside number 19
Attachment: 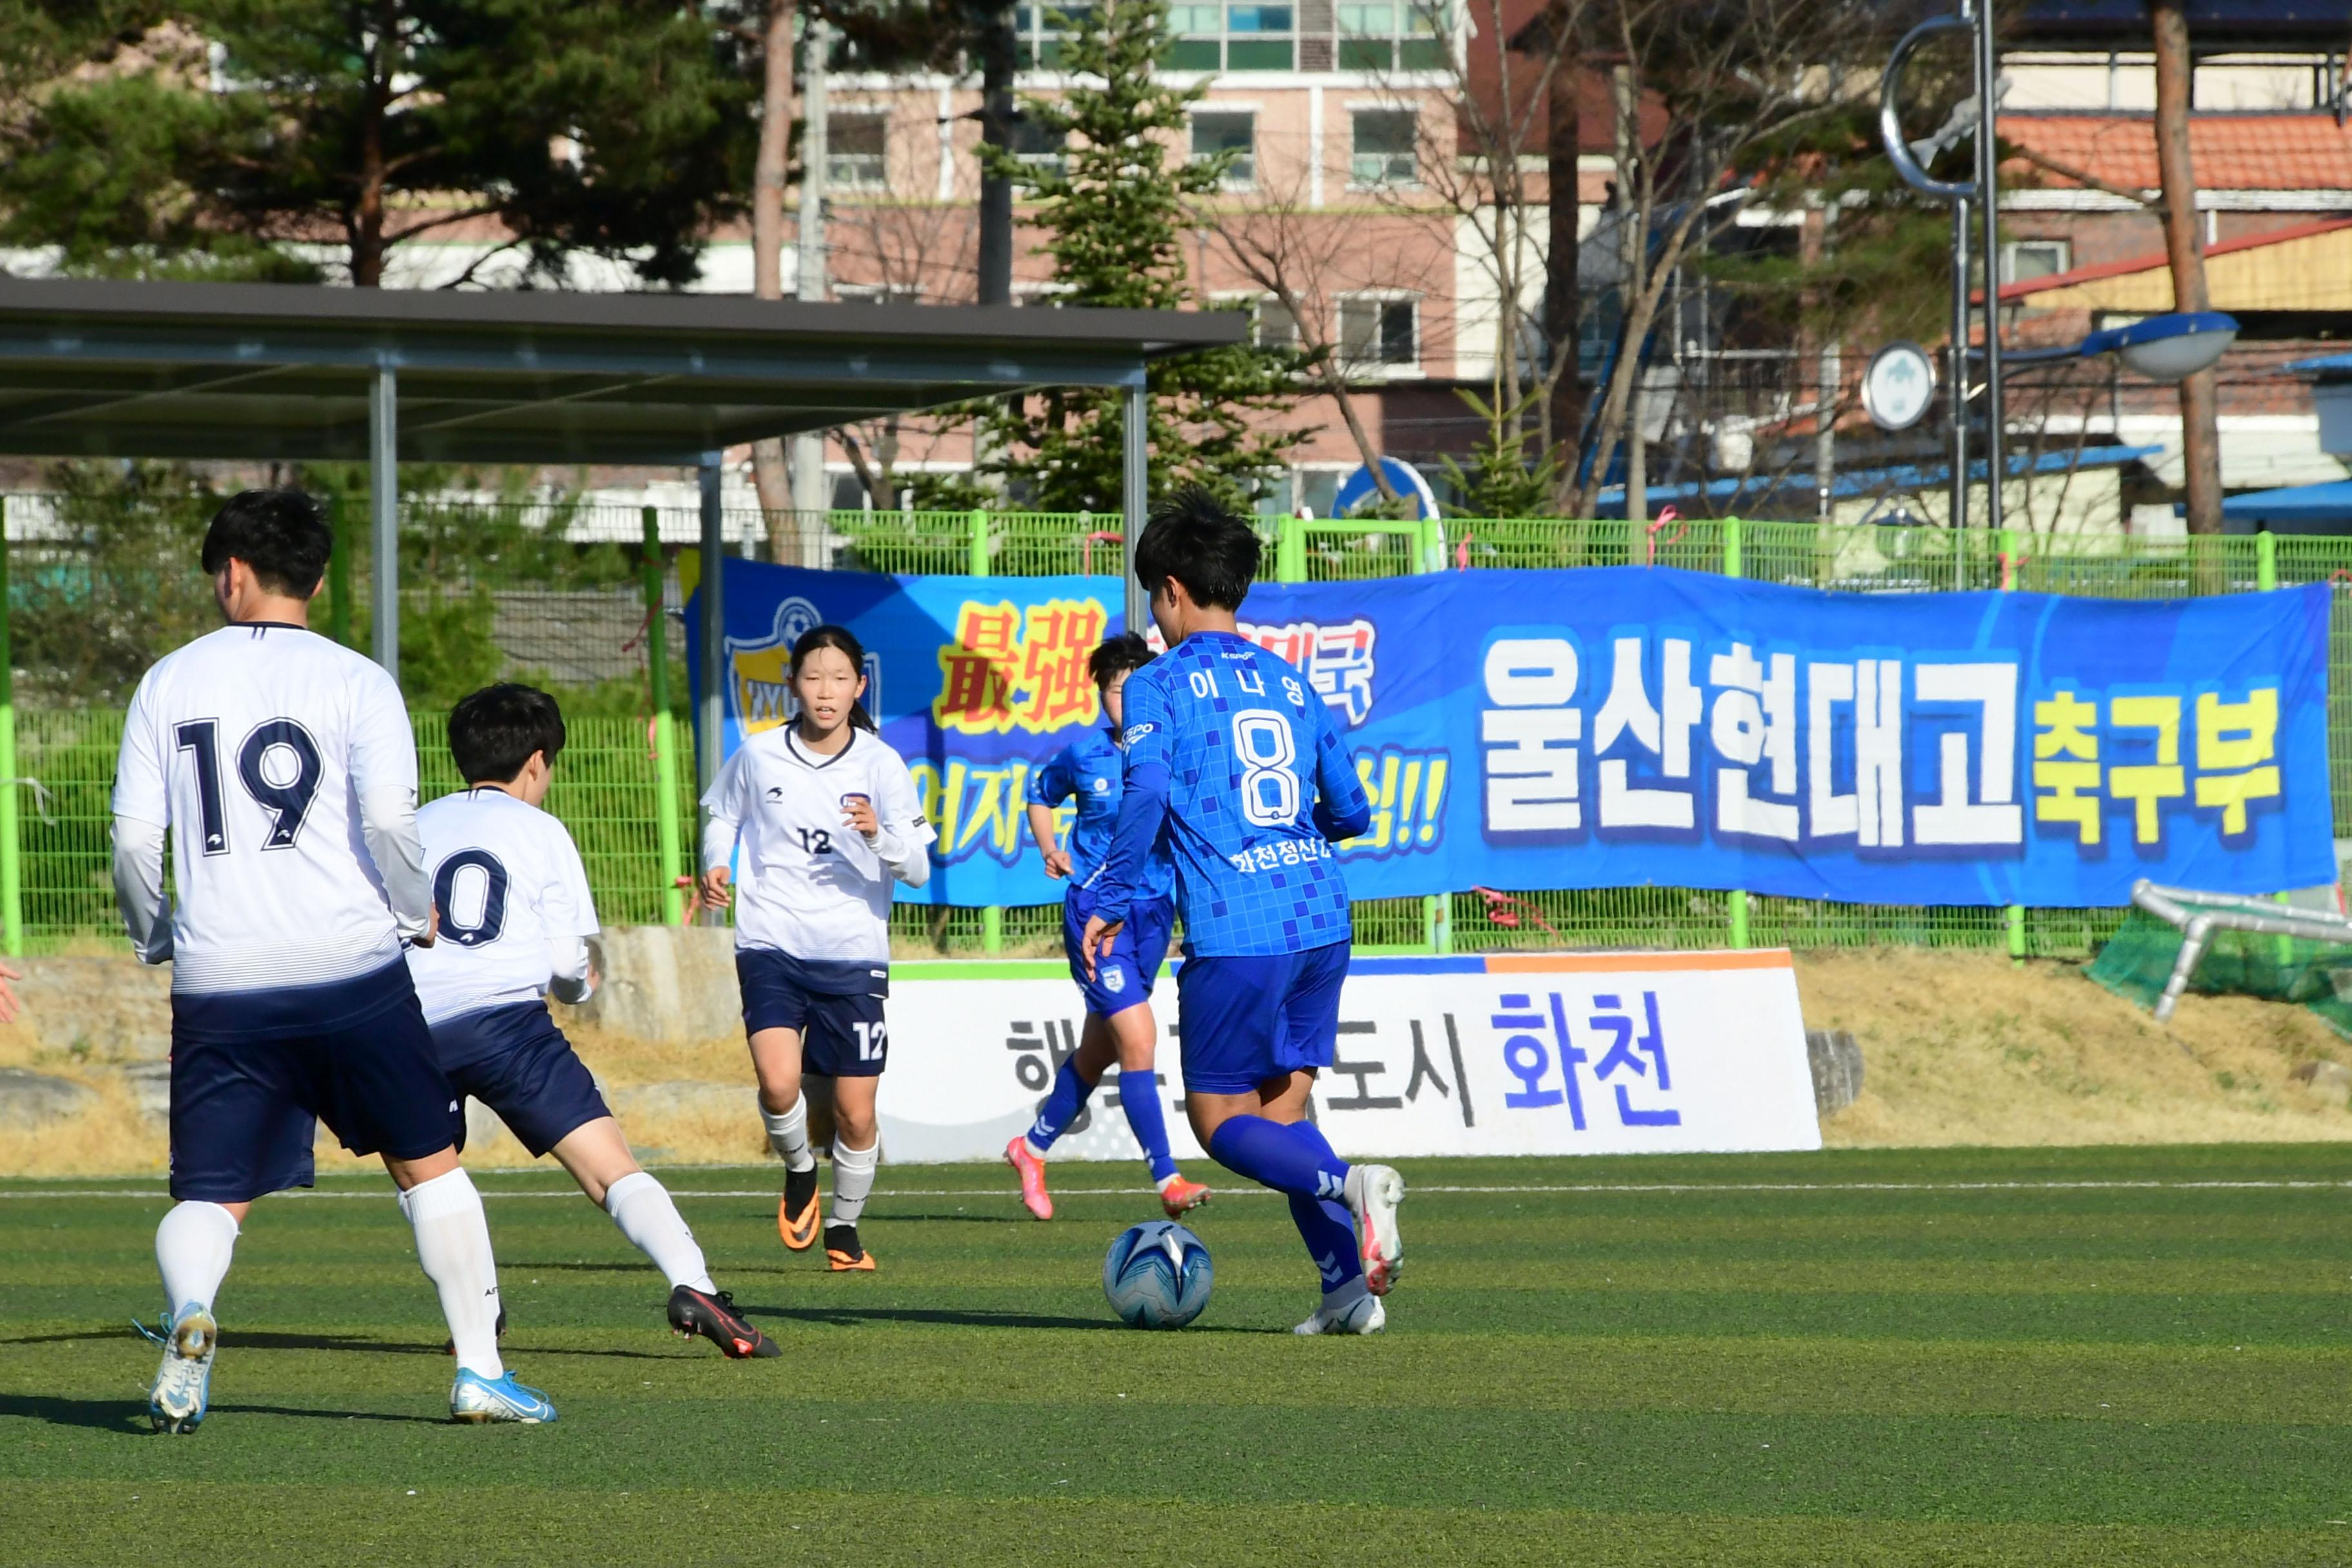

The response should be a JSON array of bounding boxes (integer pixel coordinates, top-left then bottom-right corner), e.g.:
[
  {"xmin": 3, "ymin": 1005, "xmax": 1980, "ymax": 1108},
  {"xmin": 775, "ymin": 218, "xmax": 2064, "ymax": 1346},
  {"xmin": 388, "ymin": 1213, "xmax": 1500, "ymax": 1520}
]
[{"xmin": 409, "ymin": 684, "xmax": 783, "ymax": 1358}]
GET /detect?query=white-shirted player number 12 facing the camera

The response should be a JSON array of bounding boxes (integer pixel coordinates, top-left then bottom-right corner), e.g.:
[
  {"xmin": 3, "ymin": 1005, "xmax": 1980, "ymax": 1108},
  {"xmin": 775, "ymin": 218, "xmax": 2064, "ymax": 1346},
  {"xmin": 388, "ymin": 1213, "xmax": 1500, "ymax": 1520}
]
[{"xmin": 703, "ymin": 625, "xmax": 939, "ymax": 1272}]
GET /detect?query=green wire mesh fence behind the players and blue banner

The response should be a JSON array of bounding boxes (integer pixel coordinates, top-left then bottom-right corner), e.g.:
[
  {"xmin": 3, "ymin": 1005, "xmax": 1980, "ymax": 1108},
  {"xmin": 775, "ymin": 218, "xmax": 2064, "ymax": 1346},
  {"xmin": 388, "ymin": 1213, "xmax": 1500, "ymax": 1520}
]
[{"xmin": 7, "ymin": 496, "xmax": 2352, "ymax": 957}]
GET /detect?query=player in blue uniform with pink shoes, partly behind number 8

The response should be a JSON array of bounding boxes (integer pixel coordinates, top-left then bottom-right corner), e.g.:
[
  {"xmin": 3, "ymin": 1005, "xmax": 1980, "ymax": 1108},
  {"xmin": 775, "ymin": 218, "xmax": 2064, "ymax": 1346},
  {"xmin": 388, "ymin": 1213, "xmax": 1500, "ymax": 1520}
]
[{"xmin": 1004, "ymin": 632, "xmax": 1209, "ymax": 1220}]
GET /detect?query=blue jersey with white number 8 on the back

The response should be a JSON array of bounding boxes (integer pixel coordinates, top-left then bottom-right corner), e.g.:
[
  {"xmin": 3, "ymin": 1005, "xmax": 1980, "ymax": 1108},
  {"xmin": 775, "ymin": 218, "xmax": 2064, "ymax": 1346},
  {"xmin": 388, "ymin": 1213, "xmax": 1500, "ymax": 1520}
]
[{"xmin": 1093, "ymin": 632, "xmax": 1371, "ymax": 957}]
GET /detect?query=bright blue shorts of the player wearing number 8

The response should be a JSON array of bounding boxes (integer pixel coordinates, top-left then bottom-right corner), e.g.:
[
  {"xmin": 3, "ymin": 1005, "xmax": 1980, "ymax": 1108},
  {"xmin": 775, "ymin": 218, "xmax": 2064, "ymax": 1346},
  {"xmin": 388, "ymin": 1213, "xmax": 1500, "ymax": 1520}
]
[{"xmin": 1176, "ymin": 943, "xmax": 1348, "ymax": 1095}]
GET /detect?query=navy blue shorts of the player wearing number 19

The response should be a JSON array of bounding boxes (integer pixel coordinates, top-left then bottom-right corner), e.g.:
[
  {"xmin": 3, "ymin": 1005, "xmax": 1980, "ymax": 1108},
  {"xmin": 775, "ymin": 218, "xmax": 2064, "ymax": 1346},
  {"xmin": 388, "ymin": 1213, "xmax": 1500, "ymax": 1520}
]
[{"xmin": 172, "ymin": 959, "xmax": 458, "ymax": 1204}]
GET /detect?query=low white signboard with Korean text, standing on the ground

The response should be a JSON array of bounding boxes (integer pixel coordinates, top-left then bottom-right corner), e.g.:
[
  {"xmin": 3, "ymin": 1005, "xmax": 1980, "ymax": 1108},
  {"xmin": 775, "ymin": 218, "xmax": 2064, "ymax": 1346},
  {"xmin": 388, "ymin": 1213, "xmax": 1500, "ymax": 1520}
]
[{"xmin": 877, "ymin": 950, "xmax": 1821, "ymax": 1161}]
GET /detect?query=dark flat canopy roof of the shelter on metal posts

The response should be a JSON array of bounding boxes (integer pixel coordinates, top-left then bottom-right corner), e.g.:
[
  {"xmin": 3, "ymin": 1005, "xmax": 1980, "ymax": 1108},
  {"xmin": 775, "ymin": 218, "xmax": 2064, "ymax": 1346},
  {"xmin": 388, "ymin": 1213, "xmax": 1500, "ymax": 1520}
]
[{"xmin": 0, "ymin": 280, "xmax": 1249, "ymax": 463}]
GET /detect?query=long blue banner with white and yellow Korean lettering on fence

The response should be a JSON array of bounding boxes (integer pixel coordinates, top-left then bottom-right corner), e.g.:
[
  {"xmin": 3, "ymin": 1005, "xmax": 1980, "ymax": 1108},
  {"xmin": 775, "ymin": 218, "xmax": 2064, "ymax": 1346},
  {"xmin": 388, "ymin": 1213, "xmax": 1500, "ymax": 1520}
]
[{"xmin": 687, "ymin": 560, "xmax": 2335, "ymax": 907}]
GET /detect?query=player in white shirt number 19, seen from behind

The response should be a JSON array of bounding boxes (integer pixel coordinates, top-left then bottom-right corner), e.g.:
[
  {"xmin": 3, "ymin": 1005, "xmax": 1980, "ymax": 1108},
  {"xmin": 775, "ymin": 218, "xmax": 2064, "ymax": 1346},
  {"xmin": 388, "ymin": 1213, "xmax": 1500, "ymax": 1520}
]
[{"xmin": 113, "ymin": 489, "xmax": 555, "ymax": 1432}]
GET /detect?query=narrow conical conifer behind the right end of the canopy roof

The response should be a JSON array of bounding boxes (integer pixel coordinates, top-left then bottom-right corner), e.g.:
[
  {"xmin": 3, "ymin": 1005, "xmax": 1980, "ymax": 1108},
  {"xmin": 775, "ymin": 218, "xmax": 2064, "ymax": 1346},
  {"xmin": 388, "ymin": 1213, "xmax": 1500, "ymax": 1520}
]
[{"xmin": 981, "ymin": 0, "xmax": 1306, "ymax": 513}]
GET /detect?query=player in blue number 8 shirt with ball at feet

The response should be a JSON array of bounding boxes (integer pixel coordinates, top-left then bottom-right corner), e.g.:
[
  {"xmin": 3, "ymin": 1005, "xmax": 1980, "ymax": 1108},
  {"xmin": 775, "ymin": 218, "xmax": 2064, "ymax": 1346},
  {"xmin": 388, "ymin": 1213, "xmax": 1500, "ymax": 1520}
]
[{"xmin": 1084, "ymin": 489, "xmax": 1404, "ymax": 1333}]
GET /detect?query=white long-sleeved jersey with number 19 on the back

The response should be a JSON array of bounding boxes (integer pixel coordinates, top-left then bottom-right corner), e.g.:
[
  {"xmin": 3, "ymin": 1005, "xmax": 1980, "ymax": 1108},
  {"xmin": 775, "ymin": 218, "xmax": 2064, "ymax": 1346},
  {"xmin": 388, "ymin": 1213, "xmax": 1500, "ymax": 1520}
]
[{"xmin": 113, "ymin": 621, "xmax": 424, "ymax": 994}]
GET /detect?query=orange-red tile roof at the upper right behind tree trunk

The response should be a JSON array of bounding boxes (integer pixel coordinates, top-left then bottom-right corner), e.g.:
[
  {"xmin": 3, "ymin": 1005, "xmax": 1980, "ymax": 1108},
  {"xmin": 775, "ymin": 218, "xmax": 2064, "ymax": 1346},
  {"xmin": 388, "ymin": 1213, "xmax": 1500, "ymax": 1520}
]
[{"xmin": 1999, "ymin": 113, "xmax": 2352, "ymax": 190}]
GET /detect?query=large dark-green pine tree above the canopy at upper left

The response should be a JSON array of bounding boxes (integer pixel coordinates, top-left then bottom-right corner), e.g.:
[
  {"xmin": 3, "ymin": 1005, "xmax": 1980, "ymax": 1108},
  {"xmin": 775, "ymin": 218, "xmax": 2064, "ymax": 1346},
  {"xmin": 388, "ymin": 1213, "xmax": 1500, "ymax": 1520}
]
[{"xmin": 0, "ymin": 0, "xmax": 750, "ymax": 287}]
